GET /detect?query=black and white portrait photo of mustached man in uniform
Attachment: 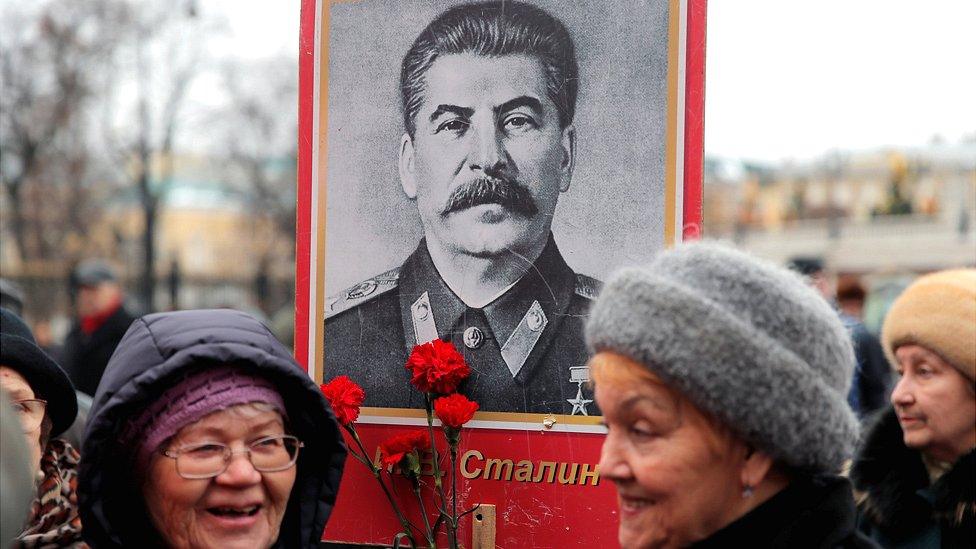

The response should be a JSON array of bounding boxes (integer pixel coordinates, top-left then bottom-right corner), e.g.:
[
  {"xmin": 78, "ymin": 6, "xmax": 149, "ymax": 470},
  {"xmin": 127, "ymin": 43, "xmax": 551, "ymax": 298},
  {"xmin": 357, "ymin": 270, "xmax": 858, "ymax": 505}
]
[{"xmin": 319, "ymin": 0, "xmax": 674, "ymax": 415}]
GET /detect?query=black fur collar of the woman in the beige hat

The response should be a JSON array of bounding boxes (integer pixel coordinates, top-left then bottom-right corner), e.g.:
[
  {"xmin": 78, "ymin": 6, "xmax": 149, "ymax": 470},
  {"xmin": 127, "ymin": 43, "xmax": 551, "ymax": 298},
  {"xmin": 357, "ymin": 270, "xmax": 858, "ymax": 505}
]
[{"xmin": 851, "ymin": 408, "xmax": 976, "ymax": 547}]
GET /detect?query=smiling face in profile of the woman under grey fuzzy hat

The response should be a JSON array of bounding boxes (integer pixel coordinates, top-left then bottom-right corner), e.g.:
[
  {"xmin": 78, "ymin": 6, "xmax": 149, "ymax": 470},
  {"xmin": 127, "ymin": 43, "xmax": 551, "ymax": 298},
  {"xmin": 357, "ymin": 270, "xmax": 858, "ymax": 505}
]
[{"xmin": 594, "ymin": 353, "xmax": 747, "ymax": 549}]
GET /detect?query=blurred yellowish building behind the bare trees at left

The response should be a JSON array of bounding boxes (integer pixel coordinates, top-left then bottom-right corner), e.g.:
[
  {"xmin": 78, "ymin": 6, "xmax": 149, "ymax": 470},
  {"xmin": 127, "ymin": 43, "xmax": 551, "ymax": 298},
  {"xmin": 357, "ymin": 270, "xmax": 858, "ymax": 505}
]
[{"xmin": 0, "ymin": 152, "xmax": 294, "ymax": 336}]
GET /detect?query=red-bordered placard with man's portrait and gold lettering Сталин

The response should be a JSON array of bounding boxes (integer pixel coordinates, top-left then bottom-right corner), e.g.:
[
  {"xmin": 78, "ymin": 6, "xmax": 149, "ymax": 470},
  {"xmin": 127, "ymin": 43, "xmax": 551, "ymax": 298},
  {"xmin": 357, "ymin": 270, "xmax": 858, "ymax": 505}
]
[{"xmin": 295, "ymin": 0, "xmax": 705, "ymax": 548}]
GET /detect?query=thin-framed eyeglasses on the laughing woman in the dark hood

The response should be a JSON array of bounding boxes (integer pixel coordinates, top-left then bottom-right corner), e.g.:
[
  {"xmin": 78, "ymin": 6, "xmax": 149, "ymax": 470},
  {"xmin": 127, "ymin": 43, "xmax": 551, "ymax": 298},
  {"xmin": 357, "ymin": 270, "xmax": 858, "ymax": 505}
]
[{"xmin": 162, "ymin": 435, "xmax": 305, "ymax": 480}]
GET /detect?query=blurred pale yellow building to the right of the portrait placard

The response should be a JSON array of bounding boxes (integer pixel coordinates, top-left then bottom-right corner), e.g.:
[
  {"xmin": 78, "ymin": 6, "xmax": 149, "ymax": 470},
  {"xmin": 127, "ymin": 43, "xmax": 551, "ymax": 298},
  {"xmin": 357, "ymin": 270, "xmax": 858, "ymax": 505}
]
[{"xmin": 703, "ymin": 140, "xmax": 976, "ymax": 331}]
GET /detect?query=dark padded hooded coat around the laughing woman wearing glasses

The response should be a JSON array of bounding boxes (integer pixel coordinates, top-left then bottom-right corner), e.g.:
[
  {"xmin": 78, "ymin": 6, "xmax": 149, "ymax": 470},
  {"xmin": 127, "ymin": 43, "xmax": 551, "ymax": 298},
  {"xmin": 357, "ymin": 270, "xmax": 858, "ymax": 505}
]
[{"xmin": 79, "ymin": 310, "xmax": 346, "ymax": 549}]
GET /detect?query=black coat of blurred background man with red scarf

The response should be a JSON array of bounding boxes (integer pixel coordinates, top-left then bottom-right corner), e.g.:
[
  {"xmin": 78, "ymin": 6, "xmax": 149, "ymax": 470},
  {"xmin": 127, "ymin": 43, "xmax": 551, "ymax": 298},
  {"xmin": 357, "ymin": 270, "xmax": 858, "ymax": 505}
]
[{"xmin": 63, "ymin": 305, "xmax": 135, "ymax": 396}]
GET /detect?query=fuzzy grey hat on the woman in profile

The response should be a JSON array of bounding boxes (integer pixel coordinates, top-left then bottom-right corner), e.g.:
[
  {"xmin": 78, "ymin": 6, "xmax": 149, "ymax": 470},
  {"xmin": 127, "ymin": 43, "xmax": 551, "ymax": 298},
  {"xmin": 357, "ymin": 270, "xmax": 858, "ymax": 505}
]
[{"xmin": 586, "ymin": 242, "xmax": 858, "ymax": 473}]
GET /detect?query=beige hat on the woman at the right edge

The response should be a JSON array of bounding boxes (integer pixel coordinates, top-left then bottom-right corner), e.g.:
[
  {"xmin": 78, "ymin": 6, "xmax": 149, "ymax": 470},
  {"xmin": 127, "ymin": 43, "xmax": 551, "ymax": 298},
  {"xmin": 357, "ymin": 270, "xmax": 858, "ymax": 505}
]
[{"xmin": 881, "ymin": 269, "xmax": 976, "ymax": 381}]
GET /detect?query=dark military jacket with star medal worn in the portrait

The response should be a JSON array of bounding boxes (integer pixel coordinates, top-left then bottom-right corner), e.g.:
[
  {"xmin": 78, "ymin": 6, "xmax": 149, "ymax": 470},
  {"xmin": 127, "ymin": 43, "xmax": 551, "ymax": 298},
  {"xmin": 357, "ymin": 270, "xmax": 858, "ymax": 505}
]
[{"xmin": 325, "ymin": 235, "xmax": 600, "ymax": 415}]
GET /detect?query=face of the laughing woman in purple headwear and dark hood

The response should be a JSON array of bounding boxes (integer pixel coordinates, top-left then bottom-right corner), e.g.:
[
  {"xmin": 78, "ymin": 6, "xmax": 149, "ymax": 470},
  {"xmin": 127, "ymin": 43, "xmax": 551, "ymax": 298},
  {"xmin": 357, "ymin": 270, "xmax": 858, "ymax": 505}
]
[{"xmin": 143, "ymin": 404, "xmax": 296, "ymax": 548}]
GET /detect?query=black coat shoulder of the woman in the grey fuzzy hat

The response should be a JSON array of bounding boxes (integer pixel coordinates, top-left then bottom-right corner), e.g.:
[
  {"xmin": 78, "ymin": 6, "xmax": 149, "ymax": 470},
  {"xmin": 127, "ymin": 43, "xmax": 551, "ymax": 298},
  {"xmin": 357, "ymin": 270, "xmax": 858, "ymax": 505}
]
[{"xmin": 693, "ymin": 476, "xmax": 877, "ymax": 549}]
